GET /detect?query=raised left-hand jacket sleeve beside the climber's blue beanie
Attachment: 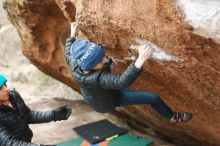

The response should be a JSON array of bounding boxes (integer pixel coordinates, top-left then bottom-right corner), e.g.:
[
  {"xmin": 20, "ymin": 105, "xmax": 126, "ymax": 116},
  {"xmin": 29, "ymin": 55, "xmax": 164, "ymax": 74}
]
[{"xmin": 65, "ymin": 37, "xmax": 75, "ymax": 65}]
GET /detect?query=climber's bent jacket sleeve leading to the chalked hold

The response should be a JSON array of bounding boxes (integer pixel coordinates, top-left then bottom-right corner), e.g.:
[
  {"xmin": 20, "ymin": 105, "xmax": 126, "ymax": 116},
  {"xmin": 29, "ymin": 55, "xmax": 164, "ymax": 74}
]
[{"xmin": 99, "ymin": 63, "xmax": 143, "ymax": 89}]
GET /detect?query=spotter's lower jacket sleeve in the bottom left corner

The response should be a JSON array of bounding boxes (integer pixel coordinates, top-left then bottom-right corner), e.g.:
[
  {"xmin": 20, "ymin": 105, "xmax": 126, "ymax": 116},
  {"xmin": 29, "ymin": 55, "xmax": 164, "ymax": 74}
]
[{"xmin": 0, "ymin": 124, "xmax": 39, "ymax": 146}]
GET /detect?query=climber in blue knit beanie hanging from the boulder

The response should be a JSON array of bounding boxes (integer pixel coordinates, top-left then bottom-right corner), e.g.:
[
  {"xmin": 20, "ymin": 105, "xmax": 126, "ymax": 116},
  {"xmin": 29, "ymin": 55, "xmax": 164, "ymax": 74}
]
[{"xmin": 65, "ymin": 22, "xmax": 192, "ymax": 123}]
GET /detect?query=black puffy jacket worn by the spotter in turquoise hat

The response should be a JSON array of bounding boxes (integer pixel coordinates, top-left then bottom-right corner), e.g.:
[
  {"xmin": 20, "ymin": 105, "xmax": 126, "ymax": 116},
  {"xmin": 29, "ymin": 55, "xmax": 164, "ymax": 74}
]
[{"xmin": 0, "ymin": 90, "xmax": 57, "ymax": 146}]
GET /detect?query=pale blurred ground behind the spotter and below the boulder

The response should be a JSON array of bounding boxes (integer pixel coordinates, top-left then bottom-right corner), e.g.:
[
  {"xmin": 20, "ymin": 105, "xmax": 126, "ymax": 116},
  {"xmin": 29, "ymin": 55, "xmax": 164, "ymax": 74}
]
[{"xmin": 0, "ymin": 1, "xmax": 176, "ymax": 146}]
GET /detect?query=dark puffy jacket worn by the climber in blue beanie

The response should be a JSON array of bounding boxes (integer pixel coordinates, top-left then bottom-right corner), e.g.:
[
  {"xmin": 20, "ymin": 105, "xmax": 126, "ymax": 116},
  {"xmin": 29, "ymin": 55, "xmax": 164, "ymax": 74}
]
[{"xmin": 65, "ymin": 38, "xmax": 142, "ymax": 113}]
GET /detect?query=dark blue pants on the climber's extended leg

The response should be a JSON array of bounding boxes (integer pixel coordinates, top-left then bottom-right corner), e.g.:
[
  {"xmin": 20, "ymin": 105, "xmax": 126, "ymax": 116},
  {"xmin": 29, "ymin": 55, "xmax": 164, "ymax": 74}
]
[{"xmin": 119, "ymin": 90, "xmax": 173, "ymax": 119}]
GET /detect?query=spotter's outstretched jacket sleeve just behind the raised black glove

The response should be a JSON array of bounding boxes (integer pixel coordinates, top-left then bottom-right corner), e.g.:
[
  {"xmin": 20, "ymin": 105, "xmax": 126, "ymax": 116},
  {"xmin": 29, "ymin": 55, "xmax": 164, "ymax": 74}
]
[{"xmin": 28, "ymin": 110, "xmax": 55, "ymax": 124}]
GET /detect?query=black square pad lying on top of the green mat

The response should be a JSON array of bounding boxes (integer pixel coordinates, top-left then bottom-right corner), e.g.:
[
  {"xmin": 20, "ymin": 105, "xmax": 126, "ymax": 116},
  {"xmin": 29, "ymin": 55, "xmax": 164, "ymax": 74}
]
[{"xmin": 73, "ymin": 119, "xmax": 128, "ymax": 144}]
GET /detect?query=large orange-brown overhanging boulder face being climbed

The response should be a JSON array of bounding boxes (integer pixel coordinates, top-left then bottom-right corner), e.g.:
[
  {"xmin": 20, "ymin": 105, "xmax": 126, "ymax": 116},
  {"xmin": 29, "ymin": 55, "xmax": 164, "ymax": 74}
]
[{"xmin": 4, "ymin": 0, "xmax": 220, "ymax": 145}]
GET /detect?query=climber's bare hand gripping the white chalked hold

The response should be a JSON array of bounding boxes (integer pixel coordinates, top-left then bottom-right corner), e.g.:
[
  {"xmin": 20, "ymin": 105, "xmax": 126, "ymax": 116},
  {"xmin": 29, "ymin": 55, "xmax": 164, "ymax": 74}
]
[{"xmin": 135, "ymin": 45, "xmax": 153, "ymax": 68}]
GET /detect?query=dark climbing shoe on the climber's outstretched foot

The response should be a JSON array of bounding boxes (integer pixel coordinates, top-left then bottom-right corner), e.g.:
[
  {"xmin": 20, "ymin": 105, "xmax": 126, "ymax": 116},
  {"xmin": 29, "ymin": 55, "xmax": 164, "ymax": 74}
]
[{"xmin": 170, "ymin": 112, "xmax": 193, "ymax": 123}]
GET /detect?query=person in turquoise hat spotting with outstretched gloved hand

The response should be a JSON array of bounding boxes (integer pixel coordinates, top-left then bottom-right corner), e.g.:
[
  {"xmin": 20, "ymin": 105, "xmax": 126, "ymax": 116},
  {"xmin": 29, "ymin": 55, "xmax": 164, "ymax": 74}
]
[{"xmin": 0, "ymin": 74, "xmax": 71, "ymax": 146}]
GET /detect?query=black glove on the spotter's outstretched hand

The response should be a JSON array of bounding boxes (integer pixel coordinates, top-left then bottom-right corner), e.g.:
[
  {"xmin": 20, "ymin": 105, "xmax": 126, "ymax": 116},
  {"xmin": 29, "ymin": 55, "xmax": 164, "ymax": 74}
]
[{"xmin": 53, "ymin": 105, "xmax": 72, "ymax": 121}]
